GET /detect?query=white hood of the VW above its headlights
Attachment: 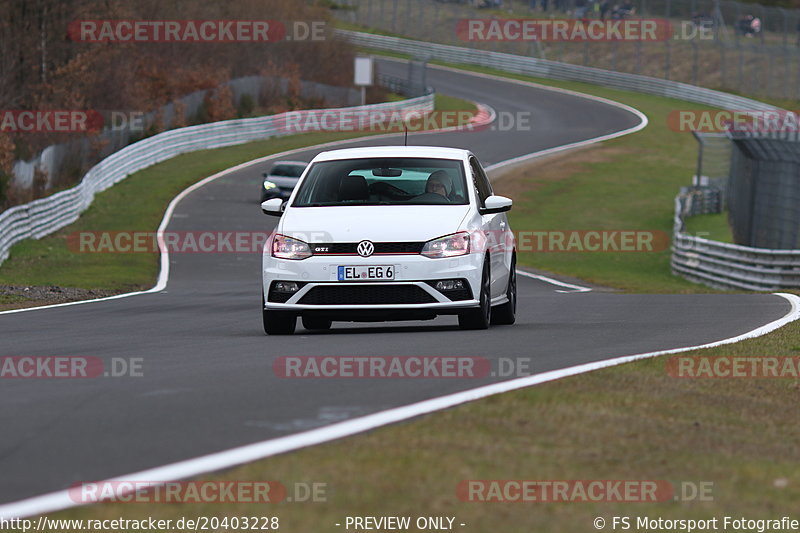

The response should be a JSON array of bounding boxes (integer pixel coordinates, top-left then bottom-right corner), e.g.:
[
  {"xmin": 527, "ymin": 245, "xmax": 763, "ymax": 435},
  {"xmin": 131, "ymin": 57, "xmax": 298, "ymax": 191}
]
[{"xmin": 278, "ymin": 205, "xmax": 470, "ymax": 242}]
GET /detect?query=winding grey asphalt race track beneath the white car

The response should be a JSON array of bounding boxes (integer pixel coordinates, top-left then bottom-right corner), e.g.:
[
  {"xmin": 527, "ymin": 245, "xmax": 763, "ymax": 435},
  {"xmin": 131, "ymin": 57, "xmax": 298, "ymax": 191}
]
[{"xmin": 0, "ymin": 62, "xmax": 789, "ymax": 503}]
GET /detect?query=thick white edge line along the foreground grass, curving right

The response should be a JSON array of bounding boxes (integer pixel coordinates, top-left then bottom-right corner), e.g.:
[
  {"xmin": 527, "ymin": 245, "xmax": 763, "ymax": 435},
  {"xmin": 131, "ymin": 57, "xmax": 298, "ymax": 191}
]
[{"xmin": 0, "ymin": 293, "xmax": 800, "ymax": 519}]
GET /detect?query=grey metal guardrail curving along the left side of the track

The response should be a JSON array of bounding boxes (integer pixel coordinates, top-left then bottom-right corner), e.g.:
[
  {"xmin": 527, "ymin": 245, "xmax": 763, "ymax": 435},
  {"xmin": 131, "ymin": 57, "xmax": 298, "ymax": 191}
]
[{"xmin": 0, "ymin": 94, "xmax": 434, "ymax": 263}]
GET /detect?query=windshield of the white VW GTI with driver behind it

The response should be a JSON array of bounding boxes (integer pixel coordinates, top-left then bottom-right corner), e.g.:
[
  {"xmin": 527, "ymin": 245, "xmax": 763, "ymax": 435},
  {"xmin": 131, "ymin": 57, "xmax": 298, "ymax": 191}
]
[{"xmin": 292, "ymin": 157, "xmax": 467, "ymax": 207}]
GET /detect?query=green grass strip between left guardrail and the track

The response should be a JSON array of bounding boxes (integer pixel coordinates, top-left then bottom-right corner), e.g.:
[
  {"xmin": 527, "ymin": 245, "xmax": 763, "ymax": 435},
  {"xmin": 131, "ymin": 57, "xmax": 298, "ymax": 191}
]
[{"xmin": 0, "ymin": 94, "xmax": 476, "ymax": 296}]
